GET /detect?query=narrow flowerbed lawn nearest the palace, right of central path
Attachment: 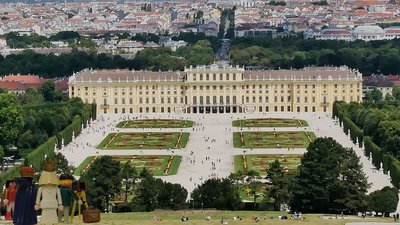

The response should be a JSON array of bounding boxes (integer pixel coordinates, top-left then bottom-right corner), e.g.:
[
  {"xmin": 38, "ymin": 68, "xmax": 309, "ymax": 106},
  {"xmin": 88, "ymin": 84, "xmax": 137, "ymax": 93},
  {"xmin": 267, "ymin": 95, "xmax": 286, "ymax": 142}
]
[{"xmin": 232, "ymin": 118, "xmax": 308, "ymax": 127}]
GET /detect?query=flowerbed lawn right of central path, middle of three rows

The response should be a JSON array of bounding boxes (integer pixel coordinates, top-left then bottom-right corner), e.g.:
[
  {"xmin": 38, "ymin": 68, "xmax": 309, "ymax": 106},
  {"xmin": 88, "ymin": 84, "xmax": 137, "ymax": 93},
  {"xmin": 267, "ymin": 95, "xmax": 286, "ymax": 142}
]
[{"xmin": 233, "ymin": 131, "xmax": 316, "ymax": 148}]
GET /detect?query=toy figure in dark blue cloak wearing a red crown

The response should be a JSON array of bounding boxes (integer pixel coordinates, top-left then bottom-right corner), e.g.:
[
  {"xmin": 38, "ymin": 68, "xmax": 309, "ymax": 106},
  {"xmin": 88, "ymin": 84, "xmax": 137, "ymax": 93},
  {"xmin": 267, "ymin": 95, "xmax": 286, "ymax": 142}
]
[{"xmin": 13, "ymin": 167, "xmax": 37, "ymax": 225}]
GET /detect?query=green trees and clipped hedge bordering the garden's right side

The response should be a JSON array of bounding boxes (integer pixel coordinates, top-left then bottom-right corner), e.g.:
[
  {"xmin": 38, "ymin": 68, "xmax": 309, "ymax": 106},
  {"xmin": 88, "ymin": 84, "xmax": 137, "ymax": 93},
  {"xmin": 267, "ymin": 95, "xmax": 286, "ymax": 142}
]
[{"xmin": 333, "ymin": 87, "xmax": 400, "ymax": 192}]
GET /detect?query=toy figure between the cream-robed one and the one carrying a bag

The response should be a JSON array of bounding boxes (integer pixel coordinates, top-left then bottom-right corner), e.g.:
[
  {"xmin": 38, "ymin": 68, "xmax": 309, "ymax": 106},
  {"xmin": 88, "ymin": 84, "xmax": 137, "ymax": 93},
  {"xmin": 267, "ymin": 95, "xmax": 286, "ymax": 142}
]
[{"xmin": 58, "ymin": 174, "xmax": 82, "ymax": 223}]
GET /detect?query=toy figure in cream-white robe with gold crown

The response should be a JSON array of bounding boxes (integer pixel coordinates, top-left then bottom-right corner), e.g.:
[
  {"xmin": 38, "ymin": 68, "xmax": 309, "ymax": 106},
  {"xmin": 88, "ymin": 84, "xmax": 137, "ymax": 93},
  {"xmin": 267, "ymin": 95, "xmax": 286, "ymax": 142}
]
[{"xmin": 35, "ymin": 160, "xmax": 63, "ymax": 224}]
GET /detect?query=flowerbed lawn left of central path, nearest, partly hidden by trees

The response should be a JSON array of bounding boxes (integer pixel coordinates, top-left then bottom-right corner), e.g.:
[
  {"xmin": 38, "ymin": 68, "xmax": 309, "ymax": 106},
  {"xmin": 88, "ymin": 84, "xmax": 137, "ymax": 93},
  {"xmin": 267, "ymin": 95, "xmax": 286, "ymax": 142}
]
[{"xmin": 74, "ymin": 155, "xmax": 182, "ymax": 176}]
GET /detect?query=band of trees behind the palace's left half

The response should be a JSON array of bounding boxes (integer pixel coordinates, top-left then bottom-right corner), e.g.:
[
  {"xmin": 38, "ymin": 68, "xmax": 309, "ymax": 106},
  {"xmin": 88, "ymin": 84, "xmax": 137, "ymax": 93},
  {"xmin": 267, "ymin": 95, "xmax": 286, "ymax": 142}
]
[{"xmin": 0, "ymin": 40, "xmax": 214, "ymax": 78}]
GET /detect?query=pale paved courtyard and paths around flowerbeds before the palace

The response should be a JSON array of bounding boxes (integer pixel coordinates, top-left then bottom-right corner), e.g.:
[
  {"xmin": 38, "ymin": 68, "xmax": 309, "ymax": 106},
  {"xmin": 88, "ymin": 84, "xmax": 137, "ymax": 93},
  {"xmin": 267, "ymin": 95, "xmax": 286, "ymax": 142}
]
[{"xmin": 60, "ymin": 113, "xmax": 399, "ymax": 209}]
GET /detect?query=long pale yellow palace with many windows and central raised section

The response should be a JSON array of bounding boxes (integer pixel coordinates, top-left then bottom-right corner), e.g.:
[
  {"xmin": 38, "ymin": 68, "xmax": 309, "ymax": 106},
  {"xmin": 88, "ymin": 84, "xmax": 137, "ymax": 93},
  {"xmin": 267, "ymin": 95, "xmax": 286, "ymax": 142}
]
[{"xmin": 69, "ymin": 65, "xmax": 362, "ymax": 113}]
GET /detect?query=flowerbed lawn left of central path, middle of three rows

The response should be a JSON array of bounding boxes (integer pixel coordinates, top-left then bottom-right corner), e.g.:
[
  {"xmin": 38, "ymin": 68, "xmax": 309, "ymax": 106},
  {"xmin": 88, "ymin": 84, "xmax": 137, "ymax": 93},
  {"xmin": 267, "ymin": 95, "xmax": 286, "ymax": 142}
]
[{"xmin": 97, "ymin": 132, "xmax": 189, "ymax": 149}]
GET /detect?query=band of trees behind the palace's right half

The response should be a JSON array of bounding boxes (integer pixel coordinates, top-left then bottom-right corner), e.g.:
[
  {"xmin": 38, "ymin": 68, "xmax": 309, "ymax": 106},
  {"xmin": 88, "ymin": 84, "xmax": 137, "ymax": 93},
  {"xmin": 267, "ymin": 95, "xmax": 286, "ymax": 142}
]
[{"xmin": 230, "ymin": 37, "xmax": 400, "ymax": 76}]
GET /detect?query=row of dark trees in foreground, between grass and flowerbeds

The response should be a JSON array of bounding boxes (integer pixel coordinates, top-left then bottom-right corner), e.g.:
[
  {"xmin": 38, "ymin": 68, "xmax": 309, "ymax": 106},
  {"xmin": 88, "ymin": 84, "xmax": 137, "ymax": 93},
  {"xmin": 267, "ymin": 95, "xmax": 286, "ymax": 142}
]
[{"xmin": 82, "ymin": 138, "xmax": 398, "ymax": 214}]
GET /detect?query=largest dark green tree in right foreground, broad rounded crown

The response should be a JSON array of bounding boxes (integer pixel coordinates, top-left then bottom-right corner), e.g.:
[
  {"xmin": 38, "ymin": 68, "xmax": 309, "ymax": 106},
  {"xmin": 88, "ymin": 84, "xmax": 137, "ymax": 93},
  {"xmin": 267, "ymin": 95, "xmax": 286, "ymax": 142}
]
[{"xmin": 290, "ymin": 138, "xmax": 368, "ymax": 213}]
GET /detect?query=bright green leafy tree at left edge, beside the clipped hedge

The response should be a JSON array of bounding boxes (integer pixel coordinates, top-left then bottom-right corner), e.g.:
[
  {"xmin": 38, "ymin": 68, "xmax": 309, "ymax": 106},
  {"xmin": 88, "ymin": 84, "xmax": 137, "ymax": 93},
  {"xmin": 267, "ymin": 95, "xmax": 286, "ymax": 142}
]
[{"xmin": 0, "ymin": 94, "xmax": 24, "ymax": 148}]
